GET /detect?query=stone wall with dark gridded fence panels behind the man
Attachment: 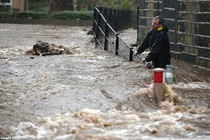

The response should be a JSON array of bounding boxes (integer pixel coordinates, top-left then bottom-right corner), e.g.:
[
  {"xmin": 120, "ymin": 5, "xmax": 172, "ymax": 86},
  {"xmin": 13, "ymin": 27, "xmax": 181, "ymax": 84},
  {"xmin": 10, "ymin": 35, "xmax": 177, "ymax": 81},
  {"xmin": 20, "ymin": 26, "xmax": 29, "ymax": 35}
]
[{"xmin": 137, "ymin": 0, "xmax": 210, "ymax": 68}]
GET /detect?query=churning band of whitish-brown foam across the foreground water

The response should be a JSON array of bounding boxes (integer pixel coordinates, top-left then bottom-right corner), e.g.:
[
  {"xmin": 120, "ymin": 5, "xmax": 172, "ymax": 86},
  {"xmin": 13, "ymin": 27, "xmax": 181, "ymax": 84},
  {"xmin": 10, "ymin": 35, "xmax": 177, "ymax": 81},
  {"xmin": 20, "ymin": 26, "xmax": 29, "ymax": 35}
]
[{"xmin": 8, "ymin": 104, "xmax": 208, "ymax": 139}]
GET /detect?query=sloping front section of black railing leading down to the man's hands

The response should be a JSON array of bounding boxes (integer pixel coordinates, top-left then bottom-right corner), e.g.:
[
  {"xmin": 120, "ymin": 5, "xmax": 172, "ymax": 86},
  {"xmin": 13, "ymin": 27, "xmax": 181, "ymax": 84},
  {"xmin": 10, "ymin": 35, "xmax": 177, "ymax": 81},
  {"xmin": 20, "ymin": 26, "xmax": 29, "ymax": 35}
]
[{"xmin": 93, "ymin": 7, "xmax": 141, "ymax": 61}]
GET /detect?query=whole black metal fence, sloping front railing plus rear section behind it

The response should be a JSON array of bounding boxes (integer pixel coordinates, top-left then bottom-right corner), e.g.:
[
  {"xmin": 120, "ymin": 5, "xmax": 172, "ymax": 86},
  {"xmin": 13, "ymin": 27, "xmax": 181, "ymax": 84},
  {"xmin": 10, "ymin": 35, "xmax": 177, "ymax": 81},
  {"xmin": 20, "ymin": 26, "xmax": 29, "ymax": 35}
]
[{"xmin": 93, "ymin": 7, "xmax": 140, "ymax": 61}]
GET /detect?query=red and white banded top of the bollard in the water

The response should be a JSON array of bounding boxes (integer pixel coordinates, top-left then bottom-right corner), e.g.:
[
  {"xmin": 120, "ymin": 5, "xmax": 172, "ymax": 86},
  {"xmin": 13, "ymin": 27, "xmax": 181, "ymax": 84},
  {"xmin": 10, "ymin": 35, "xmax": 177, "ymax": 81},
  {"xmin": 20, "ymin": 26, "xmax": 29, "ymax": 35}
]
[{"xmin": 153, "ymin": 68, "xmax": 165, "ymax": 83}]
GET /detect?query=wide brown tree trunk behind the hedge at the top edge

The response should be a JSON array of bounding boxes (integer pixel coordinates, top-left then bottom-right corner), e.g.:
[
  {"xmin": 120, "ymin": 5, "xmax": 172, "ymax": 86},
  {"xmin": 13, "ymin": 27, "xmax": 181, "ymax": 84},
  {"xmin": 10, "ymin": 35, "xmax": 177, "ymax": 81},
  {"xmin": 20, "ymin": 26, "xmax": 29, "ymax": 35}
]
[{"xmin": 49, "ymin": 0, "xmax": 67, "ymax": 14}]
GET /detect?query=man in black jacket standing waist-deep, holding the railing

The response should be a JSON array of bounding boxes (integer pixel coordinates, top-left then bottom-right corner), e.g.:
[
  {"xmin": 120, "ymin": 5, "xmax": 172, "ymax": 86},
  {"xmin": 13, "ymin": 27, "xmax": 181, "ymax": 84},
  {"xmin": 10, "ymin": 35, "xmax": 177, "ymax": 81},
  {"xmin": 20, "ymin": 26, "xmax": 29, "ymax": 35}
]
[{"xmin": 134, "ymin": 16, "xmax": 171, "ymax": 69}]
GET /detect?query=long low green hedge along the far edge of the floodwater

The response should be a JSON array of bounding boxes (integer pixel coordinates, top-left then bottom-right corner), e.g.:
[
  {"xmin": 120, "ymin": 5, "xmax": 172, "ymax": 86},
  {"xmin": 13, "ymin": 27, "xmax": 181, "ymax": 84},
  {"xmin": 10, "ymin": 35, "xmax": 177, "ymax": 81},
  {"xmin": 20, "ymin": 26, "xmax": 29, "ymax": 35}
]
[{"xmin": 0, "ymin": 11, "xmax": 93, "ymax": 20}]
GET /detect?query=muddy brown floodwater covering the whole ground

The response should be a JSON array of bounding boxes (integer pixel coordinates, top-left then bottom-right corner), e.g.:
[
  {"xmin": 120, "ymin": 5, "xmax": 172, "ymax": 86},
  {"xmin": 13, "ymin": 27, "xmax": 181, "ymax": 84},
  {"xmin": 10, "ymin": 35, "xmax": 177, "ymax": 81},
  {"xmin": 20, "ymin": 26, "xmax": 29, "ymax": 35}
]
[{"xmin": 0, "ymin": 24, "xmax": 210, "ymax": 140}]
